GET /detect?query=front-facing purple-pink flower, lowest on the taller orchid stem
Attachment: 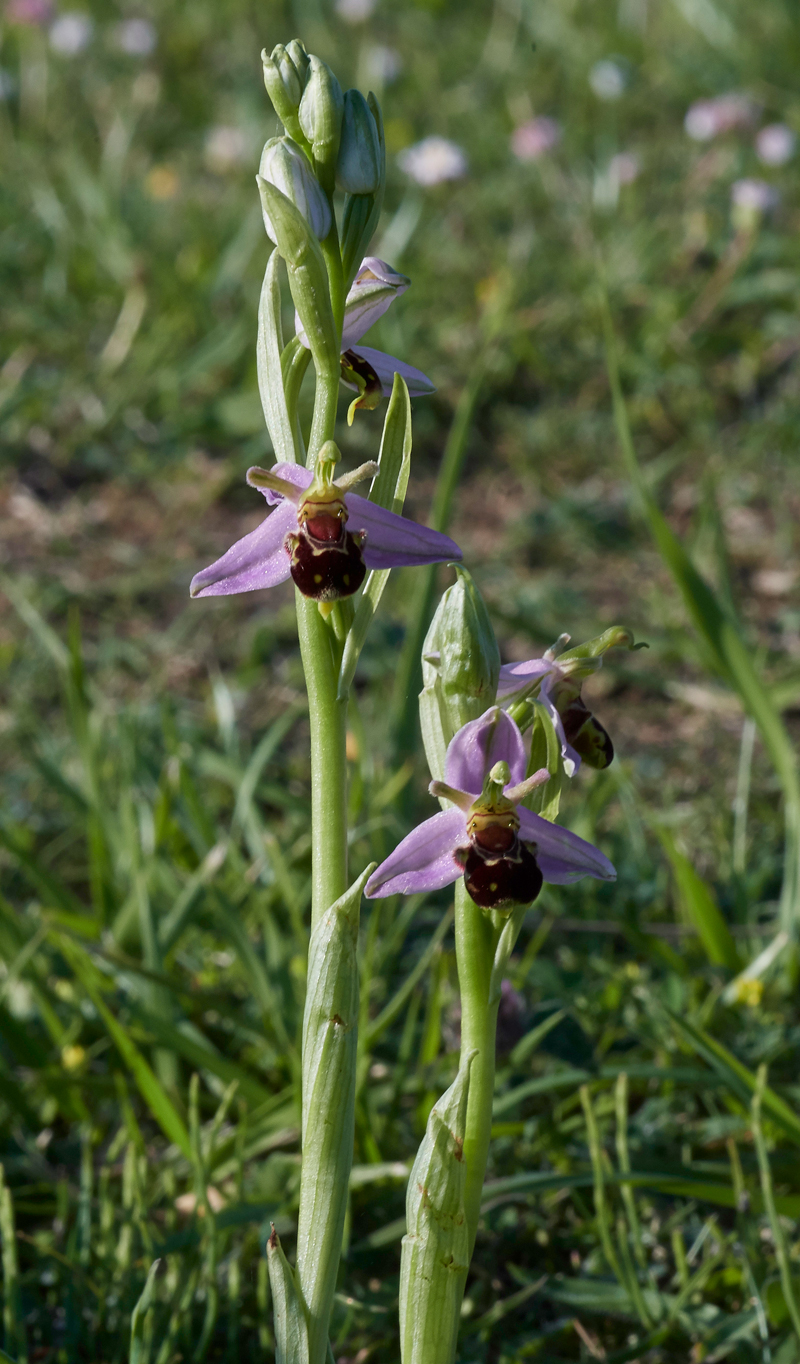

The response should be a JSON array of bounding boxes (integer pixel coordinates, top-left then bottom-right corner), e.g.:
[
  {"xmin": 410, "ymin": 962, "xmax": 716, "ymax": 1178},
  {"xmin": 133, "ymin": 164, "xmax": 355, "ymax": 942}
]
[{"xmin": 189, "ymin": 441, "xmax": 462, "ymax": 603}]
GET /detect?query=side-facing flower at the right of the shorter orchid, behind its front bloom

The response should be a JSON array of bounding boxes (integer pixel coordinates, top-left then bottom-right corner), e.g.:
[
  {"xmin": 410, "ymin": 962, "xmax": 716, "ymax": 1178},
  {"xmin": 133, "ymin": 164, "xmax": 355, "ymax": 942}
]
[{"xmin": 497, "ymin": 634, "xmax": 613, "ymax": 776}]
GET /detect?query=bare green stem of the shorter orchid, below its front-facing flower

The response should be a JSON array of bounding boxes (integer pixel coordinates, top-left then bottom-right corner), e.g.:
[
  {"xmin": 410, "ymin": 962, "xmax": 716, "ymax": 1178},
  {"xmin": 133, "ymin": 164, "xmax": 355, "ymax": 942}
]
[{"xmin": 455, "ymin": 880, "xmax": 502, "ymax": 1256}]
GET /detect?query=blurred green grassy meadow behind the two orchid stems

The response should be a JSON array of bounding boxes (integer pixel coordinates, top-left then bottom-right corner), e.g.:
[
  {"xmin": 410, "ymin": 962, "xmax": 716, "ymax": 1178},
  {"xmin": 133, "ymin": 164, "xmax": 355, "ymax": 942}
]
[{"xmin": 0, "ymin": 0, "xmax": 800, "ymax": 1364}]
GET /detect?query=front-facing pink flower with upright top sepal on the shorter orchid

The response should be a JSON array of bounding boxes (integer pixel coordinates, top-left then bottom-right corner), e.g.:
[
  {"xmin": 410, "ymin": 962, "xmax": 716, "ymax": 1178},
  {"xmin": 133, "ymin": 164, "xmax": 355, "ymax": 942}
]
[{"xmin": 367, "ymin": 707, "xmax": 616, "ymax": 913}]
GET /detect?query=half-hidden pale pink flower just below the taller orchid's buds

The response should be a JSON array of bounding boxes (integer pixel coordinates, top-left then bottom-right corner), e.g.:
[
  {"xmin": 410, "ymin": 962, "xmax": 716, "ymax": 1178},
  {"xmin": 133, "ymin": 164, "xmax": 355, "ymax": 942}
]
[{"xmin": 296, "ymin": 256, "xmax": 436, "ymax": 424}]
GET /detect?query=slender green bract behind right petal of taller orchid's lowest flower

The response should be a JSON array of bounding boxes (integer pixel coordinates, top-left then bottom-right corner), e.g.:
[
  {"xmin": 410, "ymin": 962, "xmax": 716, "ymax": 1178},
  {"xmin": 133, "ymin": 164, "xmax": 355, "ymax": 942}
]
[{"xmin": 337, "ymin": 374, "xmax": 412, "ymax": 701}]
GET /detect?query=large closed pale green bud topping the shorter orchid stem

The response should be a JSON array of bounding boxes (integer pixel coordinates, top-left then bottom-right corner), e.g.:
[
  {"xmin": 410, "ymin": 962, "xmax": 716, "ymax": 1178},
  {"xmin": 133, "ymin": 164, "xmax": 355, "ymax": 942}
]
[{"xmin": 420, "ymin": 567, "xmax": 500, "ymax": 780}]
